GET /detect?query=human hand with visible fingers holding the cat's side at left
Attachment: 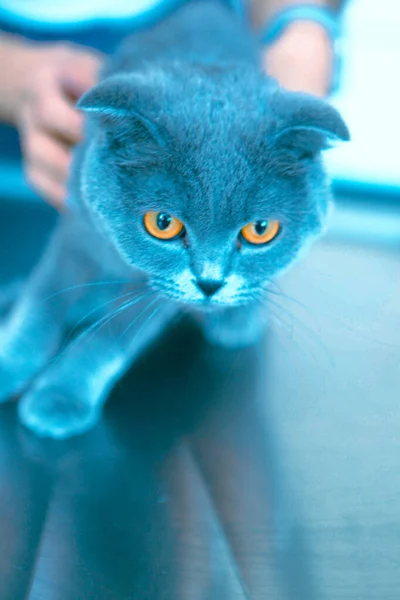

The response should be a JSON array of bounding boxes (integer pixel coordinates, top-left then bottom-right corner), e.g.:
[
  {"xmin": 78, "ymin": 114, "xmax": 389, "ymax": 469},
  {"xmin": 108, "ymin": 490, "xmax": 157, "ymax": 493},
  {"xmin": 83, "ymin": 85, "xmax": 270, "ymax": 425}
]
[{"xmin": 13, "ymin": 43, "xmax": 102, "ymax": 208}]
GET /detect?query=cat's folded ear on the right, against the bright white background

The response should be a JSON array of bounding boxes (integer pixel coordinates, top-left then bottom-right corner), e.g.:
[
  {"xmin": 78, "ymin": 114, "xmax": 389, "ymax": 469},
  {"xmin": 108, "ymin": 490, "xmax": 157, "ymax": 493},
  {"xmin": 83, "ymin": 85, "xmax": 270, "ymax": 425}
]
[{"xmin": 272, "ymin": 89, "xmax": 350, "ymax": 157}]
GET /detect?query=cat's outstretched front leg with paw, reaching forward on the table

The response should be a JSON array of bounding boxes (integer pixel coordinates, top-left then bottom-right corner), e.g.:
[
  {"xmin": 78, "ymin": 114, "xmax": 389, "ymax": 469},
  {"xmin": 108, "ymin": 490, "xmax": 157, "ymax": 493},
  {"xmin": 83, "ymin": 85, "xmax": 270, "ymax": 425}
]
[{"xmin": 19, "ymin": 295, "xmax": 177, "ymax": 438}]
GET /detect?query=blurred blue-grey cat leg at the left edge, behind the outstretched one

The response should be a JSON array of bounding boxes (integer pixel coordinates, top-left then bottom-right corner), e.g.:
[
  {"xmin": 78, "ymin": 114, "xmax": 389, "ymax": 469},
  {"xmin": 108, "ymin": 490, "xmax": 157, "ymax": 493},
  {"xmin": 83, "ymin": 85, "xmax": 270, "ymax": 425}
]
[{"xmin": 0, "ymin": 228, "xmax": 90, "ymax": 401}]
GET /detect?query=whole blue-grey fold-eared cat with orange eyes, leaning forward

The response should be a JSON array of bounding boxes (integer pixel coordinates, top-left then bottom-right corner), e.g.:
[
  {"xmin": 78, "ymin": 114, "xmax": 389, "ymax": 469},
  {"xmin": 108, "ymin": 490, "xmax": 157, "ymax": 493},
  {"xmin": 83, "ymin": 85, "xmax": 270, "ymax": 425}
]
[{"xmin": 0, "ymin": 0, "xmax": 349, "ymax": 438}]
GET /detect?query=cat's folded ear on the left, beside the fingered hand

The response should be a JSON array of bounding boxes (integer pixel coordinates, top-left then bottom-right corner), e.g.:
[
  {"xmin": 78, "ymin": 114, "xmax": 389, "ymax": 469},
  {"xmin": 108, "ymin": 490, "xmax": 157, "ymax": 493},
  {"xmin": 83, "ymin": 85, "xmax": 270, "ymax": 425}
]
[{"xmin": 76, "ymin": 74, "xmax": 165, "ymax": 151}]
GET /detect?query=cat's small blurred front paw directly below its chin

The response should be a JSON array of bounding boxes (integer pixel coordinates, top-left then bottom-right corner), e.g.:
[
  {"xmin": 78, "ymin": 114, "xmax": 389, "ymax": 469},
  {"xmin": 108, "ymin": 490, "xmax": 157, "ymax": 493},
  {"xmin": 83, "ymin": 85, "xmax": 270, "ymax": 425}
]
[{"xmin": 202, "ymin": 305, "xmax": 267, "ymax": 349}]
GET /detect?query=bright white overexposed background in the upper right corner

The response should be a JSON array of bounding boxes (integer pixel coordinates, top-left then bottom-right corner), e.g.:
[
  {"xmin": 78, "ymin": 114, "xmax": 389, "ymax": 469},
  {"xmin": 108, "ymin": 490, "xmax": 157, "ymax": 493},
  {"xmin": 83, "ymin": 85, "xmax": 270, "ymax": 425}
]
[{"xmin": 328, "ymin": 0, "xmax": 400, "ymax": 195}]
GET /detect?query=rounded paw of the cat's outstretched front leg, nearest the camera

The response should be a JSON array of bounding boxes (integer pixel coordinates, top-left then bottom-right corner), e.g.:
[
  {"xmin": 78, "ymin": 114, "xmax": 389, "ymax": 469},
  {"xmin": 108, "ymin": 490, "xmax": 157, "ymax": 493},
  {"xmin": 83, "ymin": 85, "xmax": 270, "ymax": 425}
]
[{"xmin": 18, "ymin": 388, "xmax": 100, "ymax": 439}]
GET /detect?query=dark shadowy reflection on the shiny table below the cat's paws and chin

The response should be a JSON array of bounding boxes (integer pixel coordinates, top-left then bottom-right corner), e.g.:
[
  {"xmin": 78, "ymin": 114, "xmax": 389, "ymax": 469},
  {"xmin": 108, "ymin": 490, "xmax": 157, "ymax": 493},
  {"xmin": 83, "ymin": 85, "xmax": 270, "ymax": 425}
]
[{"xmin": 0, "ymin": 200, "xmax": 315, "ymax": 600}]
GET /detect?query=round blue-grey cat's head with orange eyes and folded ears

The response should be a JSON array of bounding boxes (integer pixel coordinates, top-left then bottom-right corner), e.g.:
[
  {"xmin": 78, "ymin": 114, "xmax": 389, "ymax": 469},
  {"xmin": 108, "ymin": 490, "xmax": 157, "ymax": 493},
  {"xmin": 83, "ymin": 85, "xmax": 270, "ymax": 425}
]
[{"xmin": 79, "ymin": 66, "xmax": 349, "ymax": 306}]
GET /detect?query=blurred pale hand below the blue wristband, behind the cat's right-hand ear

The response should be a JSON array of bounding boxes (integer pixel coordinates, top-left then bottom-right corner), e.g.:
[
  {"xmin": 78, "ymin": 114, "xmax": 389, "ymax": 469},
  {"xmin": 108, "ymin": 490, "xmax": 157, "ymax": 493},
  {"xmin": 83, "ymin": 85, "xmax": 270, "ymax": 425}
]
[{"xmin": 263, "ymin": 21, "xmax": 334, "ymax": 97}]
